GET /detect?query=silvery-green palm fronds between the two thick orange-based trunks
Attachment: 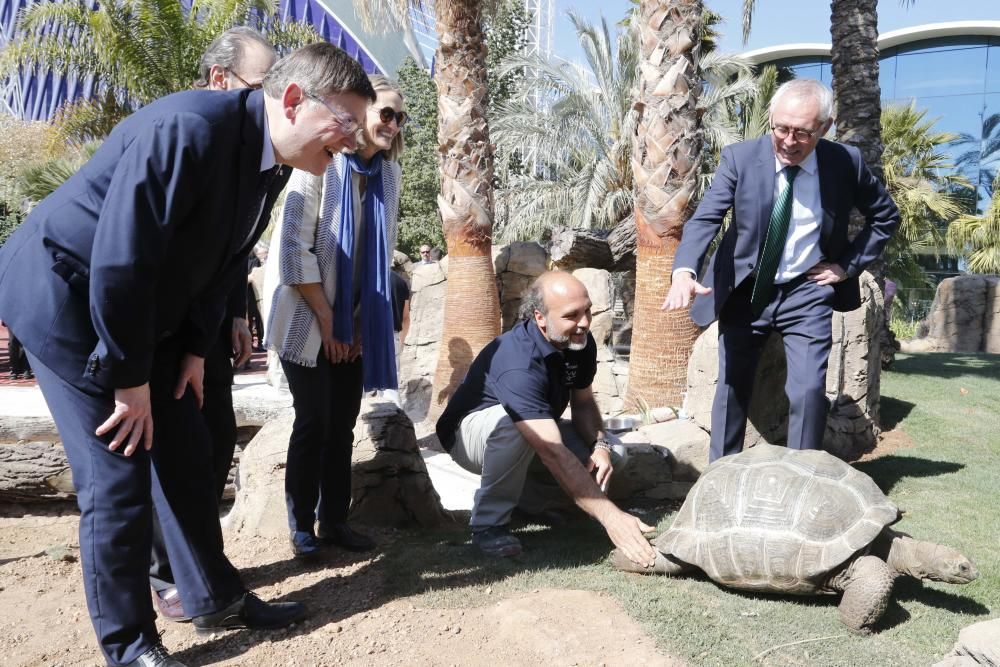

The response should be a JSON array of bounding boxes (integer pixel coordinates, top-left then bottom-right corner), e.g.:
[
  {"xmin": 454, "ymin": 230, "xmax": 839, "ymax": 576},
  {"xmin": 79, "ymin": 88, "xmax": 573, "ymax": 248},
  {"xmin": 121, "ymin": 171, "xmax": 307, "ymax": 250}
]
[{"xmin": 491, "ymin": 13, "xmax": 639, "ymax": 241}]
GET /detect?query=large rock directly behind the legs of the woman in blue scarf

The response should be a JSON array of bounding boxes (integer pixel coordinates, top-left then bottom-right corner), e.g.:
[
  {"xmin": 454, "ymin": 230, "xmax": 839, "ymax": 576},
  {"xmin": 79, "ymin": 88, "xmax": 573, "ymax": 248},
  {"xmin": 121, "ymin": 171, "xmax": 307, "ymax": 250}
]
[{"xmin": 225, "ymin": 399, "xmax": 449, "ymax": 538}]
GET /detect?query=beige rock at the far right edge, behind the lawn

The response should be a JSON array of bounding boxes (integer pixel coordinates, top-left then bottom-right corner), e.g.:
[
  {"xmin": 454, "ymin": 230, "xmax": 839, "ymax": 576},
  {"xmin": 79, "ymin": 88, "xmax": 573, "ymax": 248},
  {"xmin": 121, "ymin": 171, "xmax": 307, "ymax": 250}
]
[{"xmin": 902, "ymin": 275, "xmax": 1000, "ymax": 354}]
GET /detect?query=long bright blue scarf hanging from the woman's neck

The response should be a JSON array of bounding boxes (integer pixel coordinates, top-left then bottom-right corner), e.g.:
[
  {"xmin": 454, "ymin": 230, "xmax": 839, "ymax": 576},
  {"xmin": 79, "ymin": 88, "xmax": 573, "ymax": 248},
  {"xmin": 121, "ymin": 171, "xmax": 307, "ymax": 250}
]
[{"xmin": 333, "ymin": 153, "xmax": 399, "ymax": 391}]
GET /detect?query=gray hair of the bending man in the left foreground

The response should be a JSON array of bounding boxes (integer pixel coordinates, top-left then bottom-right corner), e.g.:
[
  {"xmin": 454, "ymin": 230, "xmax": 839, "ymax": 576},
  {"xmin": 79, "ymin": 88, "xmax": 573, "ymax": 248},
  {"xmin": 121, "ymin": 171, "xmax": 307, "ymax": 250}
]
[{"xmin": 264, "ymin": 42, "xmax": 375, "ymax": 102}]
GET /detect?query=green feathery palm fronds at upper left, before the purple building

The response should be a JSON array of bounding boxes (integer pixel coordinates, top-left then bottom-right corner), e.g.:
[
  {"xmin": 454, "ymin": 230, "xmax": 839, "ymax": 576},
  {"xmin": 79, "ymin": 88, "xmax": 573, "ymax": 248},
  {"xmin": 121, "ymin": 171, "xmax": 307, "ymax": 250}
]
[{"xmin": 0, "ymin": 0, "xmax": 320, "ymax": 142}]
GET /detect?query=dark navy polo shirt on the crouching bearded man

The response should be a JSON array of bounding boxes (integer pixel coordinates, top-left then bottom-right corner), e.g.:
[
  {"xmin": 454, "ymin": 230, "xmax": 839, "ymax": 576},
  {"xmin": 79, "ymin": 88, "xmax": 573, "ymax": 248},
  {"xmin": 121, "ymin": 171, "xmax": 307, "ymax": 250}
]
[{"xmin": 436, "ymin": 320, "xmax": 597, "ymax": 450}]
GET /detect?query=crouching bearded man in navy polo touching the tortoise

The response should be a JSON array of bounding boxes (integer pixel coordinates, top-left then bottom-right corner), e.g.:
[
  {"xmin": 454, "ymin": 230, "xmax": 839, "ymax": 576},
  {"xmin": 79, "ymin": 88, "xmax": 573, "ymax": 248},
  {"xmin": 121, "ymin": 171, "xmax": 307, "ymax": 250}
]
[{"xmin": 437, "ymin": 271, "xmax": 654, "ymax": 564}]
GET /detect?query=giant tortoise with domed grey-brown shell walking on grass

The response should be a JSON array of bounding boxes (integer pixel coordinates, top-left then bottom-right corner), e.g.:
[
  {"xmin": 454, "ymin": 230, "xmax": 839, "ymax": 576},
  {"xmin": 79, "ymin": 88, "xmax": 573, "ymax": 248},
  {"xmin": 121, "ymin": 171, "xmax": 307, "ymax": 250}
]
[{"xmin": 611, "ymin": 444, "xmax": 979, "ymax": 634}]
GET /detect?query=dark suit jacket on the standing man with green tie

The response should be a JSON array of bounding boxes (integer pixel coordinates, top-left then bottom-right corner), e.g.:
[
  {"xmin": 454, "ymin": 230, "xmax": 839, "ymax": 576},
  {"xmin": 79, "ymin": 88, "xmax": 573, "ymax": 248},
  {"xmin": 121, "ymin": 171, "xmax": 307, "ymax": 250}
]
[{"xmin": 674, "ymin": 135, "xmax": 899, "ymax": 326}]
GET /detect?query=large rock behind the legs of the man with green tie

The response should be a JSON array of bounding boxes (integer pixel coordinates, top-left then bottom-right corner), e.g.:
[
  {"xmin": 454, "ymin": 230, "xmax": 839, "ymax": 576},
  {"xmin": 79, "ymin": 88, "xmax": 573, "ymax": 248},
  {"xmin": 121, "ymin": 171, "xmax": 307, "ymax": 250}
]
[{"xmin": 684, "ymin": 273, "xmax": 883, "ymax": 460}]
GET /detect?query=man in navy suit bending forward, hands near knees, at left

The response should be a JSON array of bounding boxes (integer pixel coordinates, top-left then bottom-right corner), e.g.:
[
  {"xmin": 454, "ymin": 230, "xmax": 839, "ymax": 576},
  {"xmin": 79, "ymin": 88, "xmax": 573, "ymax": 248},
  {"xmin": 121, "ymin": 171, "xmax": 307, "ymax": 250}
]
[{"xmin": 0, "ymin": 43, "xmax": 375, "ymax": 667}]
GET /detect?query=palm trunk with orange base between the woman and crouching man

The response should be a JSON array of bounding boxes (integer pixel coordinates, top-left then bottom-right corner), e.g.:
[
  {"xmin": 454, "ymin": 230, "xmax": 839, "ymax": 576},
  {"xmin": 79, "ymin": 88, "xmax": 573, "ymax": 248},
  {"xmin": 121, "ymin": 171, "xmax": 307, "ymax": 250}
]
[{"xmin": 428, "ymin": 0, "xmax": 500, "ymax": 418}]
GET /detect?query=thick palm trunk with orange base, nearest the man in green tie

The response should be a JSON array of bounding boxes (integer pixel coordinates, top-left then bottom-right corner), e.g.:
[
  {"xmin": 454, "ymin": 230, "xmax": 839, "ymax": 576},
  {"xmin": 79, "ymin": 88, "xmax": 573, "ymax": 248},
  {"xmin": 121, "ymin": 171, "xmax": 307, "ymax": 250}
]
[{"xmin": 626, "ymin": 0, "xmax": 703, "ymax": 408}]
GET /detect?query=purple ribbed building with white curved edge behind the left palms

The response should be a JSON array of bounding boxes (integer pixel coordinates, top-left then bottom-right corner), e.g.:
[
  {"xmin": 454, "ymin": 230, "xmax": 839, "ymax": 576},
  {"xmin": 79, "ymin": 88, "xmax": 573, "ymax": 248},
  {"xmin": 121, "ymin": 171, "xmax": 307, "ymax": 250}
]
[{"xmin": 0, "ymin": 0, "xmax": 423, "ymax": 120}]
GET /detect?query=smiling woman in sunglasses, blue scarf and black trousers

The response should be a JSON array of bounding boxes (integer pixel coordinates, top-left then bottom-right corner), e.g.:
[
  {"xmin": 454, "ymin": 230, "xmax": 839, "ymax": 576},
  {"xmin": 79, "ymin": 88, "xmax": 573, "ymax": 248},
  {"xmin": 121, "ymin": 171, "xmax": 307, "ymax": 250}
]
[{"xmin": 265, "ymin": 75, "xmax": 406, "ymax": 557}]
